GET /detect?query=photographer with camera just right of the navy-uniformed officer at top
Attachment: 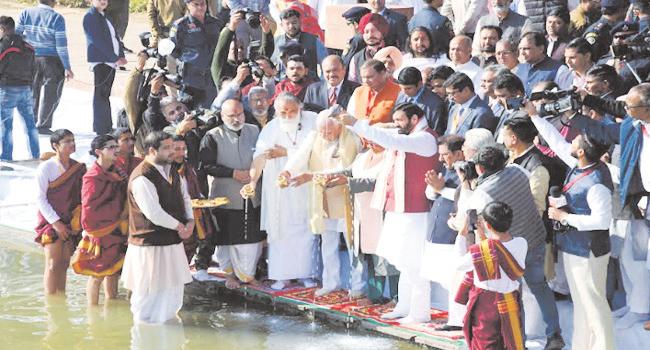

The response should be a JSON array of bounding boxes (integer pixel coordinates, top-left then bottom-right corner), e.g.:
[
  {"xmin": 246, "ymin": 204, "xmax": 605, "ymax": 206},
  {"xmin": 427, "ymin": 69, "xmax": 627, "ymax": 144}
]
[{"xmin": 210, "ymin": 12, "xmax": 275, "ymax": 91}]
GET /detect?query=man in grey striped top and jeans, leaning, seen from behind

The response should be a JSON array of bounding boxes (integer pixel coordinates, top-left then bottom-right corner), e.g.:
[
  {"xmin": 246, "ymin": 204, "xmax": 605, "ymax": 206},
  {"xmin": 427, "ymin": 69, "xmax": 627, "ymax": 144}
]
[{"xmin": 470, "ymin": 145, "xmax": 564, "ymax": 350}]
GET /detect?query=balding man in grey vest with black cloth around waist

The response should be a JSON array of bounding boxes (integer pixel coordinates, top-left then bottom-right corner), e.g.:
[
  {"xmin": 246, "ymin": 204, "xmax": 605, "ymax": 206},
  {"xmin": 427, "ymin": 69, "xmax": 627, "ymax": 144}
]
[{"xmin": 200, "ymin": 100, "xmax": 266, "ymax": 288}]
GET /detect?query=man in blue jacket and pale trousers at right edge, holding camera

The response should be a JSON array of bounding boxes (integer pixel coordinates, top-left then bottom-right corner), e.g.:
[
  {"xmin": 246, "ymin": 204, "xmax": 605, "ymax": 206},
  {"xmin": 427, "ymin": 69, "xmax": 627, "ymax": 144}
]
[{"xmin": 568, "ymin": 83, "xmax": 650, "ymax": 329}]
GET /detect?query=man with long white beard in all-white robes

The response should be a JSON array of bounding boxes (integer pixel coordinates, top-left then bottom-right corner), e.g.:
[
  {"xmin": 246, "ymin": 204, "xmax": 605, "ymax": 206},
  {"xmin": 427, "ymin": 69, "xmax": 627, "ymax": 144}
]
[{"xmin": 241, "ymin": 92, "xmax": 316, "ymax": 290}]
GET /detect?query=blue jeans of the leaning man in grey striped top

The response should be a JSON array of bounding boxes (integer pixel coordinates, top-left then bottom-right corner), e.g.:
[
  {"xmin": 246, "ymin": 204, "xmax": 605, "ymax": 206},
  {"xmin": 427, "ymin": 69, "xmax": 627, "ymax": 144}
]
[{"xmin": 522, "ymin": 243, "xmax": 562, "ymax": 337}]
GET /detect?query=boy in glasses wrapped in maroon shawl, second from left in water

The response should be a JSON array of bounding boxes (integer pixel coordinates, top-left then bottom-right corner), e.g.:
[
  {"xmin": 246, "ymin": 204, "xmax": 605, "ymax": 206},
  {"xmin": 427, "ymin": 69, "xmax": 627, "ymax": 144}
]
[{"xmin": 71, "ymin": 135, "xmax": 129, "ymax": 305}]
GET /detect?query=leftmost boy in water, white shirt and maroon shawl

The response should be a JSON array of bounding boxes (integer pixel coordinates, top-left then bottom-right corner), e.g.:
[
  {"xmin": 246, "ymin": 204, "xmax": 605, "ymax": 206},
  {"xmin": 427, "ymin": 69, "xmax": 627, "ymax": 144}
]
[{"xmin": 35, "ymin": 129, "xmax": 86, "ymax": 294}]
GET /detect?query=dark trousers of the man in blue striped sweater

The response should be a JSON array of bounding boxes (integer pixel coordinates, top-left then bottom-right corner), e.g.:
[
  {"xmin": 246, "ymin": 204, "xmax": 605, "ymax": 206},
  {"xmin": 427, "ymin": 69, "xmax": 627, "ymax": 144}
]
[{"xmin": 32, "ymin": 56, "xmax": 65, "ymax": 129}]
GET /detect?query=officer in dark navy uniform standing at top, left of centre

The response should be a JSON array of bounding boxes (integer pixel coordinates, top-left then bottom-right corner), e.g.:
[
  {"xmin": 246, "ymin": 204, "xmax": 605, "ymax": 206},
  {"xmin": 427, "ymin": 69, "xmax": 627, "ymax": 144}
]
[{"xmin": 169, "ymin": 0, "xmax": 225, "ymax": 108}]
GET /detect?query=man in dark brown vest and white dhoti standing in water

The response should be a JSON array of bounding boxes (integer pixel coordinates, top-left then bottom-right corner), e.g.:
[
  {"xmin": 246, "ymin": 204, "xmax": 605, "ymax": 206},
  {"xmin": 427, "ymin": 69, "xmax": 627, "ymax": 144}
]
[{"xmin": 122, "ymin": 131, "xmax": 194, "ymax": 324}]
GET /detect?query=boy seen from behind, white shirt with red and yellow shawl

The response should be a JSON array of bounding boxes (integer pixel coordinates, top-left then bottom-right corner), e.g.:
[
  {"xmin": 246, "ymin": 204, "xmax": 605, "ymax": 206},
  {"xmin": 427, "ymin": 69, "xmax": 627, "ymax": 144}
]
[{"xmin": 456, "ymin": 202, "xmax": 528, "ymax": 350}]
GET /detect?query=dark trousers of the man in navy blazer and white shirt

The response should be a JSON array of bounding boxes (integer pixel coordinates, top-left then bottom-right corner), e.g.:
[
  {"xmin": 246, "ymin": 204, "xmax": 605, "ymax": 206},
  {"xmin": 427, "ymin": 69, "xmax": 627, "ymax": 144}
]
[{"xmin": 93, "ymin": 63, "xmax": 115, "ymax": 135}]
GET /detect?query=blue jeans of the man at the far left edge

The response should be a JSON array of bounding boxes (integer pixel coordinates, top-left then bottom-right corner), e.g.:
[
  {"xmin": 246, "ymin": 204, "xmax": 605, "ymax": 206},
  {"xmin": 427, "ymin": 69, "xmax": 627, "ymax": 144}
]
[{"xmin": 0, "ymin": 86, "xmax": 41, "ymax": 161}]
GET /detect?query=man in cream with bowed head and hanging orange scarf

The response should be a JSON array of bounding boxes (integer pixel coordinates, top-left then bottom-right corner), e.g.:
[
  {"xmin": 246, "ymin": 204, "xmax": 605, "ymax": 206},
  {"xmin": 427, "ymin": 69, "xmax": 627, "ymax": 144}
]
[{"xmin": 281, "ymin": 109, "xmax": 365, "ymax": 298}]
